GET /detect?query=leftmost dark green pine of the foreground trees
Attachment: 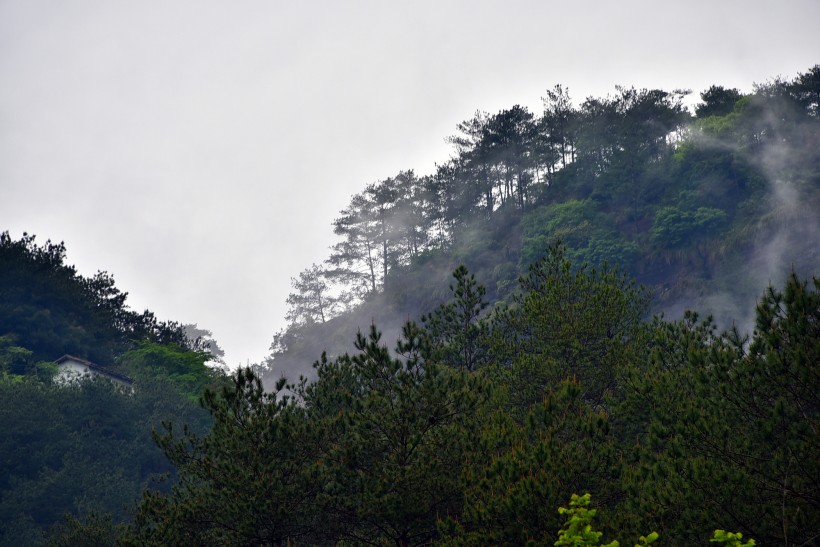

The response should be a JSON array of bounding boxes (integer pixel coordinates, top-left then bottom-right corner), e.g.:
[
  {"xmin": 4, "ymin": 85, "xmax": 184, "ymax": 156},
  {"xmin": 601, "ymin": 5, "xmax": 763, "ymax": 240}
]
[{"xmin": 125, "ymin": 369, "xmax": 318, "ymax": 545}]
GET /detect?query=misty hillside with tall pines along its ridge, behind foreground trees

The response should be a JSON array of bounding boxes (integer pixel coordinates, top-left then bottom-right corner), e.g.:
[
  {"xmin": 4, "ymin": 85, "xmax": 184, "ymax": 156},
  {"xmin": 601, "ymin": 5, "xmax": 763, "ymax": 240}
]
[{"xmin": 266, "ymin": 66, "xmax": 820, "ymax": 383}]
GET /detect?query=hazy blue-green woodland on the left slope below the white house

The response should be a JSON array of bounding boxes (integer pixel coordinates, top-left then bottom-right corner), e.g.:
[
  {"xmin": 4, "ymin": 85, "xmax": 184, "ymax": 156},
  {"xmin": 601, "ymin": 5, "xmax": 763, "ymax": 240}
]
[{"xmin": 0, "ymin": 368, "xmax": 206, "ymax": 547}]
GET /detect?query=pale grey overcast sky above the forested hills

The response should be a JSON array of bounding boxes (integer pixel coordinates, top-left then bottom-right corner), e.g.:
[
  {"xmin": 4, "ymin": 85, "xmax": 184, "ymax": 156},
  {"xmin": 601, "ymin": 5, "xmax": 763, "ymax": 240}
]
[{"xmin": 0, "ymin": 0, "xmax": 820, "ymax": 366}]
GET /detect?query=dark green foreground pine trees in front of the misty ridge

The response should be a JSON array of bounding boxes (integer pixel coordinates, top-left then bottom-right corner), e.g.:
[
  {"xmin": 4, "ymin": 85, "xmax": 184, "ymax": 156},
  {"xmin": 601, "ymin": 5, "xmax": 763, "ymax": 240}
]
[{"xmin": 73, "ymin": 250, "xmax": 820, "ymax": 547}]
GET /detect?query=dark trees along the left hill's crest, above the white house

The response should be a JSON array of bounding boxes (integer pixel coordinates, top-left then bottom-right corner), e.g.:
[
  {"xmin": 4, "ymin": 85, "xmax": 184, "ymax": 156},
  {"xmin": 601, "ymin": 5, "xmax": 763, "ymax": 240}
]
[{"xmin": 0, "ymin": 232, "xmax": 191, "ymax": 363}]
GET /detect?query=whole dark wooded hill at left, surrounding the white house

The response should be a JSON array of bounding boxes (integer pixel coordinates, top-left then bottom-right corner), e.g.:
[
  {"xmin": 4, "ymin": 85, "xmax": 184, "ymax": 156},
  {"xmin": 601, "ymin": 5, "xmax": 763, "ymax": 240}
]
[{"xmin": 0, "ymin": 232, "xmax": 225, "ymax": 547}]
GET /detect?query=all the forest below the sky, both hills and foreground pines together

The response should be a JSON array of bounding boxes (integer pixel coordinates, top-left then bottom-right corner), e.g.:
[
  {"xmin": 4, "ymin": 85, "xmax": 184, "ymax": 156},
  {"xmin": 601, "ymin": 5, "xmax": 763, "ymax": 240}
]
[{"xmin": 0, "ymin": 65, "xmax": 820, "ymax": 546}]
